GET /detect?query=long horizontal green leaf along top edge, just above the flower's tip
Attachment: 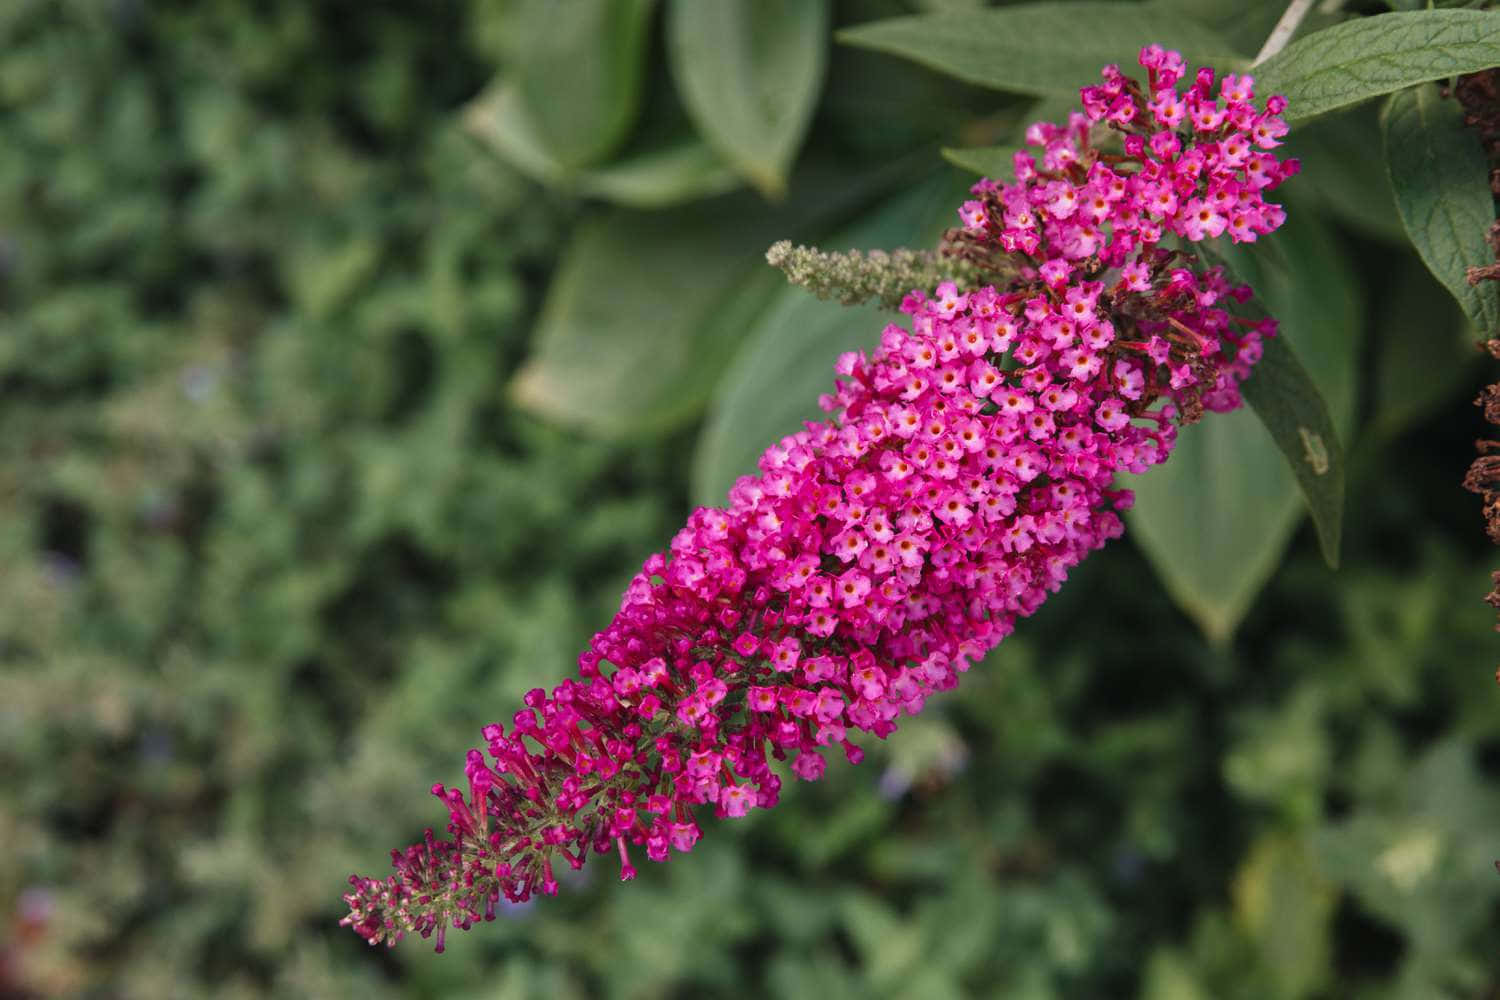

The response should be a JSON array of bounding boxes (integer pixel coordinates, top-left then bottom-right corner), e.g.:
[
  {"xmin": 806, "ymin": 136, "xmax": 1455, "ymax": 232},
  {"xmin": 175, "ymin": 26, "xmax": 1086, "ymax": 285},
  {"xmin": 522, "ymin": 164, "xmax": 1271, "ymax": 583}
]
[{"xmin": 836, "ymin": 0, "xmax": 1242, "ymax": 96}]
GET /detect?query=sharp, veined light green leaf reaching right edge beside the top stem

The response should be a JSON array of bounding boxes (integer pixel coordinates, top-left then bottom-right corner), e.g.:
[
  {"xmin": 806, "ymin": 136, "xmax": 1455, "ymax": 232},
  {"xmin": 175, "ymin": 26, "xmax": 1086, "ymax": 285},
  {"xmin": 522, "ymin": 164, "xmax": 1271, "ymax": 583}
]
[{"xmin": 1256, "ymin": 10, "xmax": 1500, "ymax": 121}]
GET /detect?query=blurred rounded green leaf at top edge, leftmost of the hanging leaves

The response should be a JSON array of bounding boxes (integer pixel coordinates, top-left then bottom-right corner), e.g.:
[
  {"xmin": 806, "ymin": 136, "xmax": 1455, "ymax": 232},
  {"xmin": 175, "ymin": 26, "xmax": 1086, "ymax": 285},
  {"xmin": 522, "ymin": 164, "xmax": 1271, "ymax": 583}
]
[{"xmin": 513, "ymin": 0, "xmax": 656, "ymax": 168}]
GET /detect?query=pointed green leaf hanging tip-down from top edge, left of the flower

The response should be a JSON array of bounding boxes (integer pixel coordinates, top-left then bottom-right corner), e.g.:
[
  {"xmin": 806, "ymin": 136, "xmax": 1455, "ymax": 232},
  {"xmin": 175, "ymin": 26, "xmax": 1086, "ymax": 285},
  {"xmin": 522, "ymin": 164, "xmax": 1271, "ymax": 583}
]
[{"xmin": 668, "ymin": 0, "xmax": 828, "ymax": 198}]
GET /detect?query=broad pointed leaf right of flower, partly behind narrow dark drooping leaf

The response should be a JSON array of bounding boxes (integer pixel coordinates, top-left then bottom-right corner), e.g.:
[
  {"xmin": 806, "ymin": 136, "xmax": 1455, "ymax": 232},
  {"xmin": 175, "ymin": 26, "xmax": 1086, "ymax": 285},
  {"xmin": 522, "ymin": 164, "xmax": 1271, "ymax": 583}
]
[{"xmin": 1130, "ymin": 211, "xmax": 1361, "ymax": 642}]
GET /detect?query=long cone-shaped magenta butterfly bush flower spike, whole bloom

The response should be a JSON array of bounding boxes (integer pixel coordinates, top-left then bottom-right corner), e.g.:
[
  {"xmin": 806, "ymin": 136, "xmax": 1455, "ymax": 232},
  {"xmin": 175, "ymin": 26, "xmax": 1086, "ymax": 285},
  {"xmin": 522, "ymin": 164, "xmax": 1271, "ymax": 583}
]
[{"xmin": 344, "ymin": 46, "xmax": 1296, "ymax": 951}]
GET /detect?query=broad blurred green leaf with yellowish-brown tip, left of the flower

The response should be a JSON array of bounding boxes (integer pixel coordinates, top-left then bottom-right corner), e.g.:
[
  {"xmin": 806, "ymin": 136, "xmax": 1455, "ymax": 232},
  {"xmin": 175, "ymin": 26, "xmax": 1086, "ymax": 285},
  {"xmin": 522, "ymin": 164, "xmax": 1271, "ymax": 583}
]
[{"xmin": 512, "ymin": 164, "xmax": 912, "ymax": 438}]
